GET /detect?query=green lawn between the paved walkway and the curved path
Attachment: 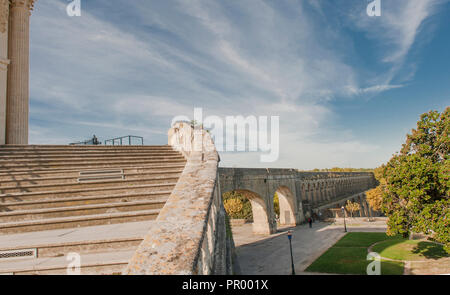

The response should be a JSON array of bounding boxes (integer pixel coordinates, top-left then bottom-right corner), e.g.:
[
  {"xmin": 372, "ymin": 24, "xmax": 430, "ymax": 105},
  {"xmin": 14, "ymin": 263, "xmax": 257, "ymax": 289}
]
[{"xmin": 306, "ymin": 232, "xmax": 404, "ymax": 275}]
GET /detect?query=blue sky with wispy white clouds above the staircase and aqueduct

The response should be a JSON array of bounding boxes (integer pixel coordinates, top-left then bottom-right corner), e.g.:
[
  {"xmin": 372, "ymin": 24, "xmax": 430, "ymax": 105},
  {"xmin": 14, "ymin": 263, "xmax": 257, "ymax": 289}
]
[{"xmin": 30, "ymin": 0, "xmax": 450, "ymax": 170}]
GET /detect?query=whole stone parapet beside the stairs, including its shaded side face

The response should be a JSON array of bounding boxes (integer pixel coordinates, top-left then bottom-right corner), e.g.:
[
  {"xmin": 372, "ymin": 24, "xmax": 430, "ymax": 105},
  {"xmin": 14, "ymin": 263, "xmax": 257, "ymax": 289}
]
[{"xmin": 124, "ymin": 122, "xmax": 234, "ymax": 275}]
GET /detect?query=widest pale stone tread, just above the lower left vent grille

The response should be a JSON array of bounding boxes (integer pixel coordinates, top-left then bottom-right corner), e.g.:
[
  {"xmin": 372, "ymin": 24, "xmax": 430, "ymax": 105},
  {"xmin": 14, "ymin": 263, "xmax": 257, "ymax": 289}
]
[{"xmin": 0, "ymin": 221, "xmax": 153, "ymax": 263}]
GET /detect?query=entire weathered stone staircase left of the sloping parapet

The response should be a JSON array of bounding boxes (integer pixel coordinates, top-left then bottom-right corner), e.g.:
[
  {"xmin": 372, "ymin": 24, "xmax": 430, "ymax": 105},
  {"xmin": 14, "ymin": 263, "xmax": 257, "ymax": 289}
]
[{"xmin": 0, "ymin": 145, "xmax": 186, "ymax": 274}]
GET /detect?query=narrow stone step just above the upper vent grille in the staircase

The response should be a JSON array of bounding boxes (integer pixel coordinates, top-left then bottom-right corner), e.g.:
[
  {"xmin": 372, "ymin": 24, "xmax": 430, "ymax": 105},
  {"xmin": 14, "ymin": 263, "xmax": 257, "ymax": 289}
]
[{"xmin": 0, "ymin": 158, "xmax": 186, "ymax": 174}]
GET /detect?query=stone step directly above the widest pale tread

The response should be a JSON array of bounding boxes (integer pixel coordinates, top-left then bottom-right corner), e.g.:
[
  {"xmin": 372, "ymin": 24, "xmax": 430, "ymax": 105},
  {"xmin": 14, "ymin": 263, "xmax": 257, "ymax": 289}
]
[{"xmin": 0, "ymin": 209, "xmax": 160, "ymax": 235}]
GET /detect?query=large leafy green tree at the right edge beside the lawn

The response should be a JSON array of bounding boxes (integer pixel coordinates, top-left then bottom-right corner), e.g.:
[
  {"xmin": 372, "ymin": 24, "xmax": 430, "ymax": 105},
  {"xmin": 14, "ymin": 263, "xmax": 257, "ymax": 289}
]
[{"xmin": 382, "ymin": 107, "xmax": 450, "ymax": 253}]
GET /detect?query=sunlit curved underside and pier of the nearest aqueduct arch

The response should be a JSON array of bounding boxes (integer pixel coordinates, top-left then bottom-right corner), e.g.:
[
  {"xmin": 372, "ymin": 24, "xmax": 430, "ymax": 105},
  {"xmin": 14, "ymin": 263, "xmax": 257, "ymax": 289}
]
[{"xmin": 235, "ymin": 189, "xmax": 276, "ymax": 235}]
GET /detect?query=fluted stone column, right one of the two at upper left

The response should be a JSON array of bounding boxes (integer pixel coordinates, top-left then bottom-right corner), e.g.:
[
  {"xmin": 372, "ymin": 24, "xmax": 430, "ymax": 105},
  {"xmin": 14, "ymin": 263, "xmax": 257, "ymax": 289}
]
[{"xmin": 6, "ymin": 0, "xmax": 34, "ymax": 144}]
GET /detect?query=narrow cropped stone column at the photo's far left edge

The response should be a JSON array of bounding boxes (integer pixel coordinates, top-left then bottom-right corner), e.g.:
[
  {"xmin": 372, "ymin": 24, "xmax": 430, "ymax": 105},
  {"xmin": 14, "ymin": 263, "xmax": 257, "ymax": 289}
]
[{"xmin": 0, "ymin": 0, "xmax": 9, "ymax": 144}]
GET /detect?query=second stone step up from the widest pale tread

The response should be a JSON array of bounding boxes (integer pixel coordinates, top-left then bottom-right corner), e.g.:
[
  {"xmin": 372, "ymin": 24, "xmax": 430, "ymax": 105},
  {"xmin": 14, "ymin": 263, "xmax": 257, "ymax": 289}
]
[{"xmin": 0, "ymin": 199, "xmax": 167, "ymax": 224}]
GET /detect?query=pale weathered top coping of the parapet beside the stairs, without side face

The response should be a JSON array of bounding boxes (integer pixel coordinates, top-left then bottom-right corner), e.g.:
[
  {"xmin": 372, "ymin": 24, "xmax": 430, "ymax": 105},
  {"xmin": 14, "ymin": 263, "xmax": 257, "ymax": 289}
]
[{"xmin": 124, "ymin": 122, "xmax": 219, "ymax": 275}]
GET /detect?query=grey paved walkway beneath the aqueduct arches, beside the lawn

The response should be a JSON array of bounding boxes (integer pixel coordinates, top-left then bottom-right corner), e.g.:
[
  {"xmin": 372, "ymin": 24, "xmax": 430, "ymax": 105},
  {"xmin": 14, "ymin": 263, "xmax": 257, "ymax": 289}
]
[{"xmin": 233, "ymin": 222, "xmax": 386, "ymax": 275}]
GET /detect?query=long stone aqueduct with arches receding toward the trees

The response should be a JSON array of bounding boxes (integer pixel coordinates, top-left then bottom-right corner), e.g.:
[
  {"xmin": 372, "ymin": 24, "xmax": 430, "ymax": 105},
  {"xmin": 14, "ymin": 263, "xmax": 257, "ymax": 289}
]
[{"xmin": 219, "ymin": 168, "xmax": 375, "ymax": 234}]
